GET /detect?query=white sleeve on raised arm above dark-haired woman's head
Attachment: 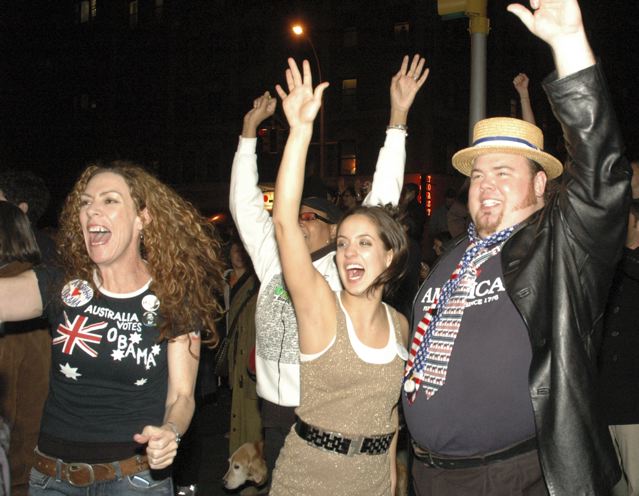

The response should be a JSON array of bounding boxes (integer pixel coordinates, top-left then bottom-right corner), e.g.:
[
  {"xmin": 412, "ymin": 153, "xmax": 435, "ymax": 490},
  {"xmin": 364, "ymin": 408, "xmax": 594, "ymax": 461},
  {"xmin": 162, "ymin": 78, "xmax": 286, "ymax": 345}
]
[{"xmin": 363, "ymin": 129, "xmax": 406, "ymax": 206}]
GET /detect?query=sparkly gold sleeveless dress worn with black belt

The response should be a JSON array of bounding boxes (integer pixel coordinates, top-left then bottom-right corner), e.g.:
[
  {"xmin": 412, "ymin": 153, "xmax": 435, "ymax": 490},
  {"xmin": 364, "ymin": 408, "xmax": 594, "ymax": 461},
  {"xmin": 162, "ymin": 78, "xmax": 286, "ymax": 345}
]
[{"xmin": 269, "ymin": 294, "xmax": 404, "ymax": 496}]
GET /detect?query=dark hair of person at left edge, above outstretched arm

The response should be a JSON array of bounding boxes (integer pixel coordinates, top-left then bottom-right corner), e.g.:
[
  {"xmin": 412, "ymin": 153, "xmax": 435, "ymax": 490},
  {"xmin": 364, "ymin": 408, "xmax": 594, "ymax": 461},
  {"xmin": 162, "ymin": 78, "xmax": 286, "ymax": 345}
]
[{"xmin": 0, "ymin": 201, "xmax": 40, "ymax": 265}]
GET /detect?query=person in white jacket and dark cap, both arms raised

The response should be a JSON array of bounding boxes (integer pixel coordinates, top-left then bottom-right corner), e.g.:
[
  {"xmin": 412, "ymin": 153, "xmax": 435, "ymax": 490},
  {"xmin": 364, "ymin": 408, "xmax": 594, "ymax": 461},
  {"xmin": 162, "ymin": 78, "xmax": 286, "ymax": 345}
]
[{"xmin": 229, "ymin": 55, "xmax": 429, "ymax": 472}]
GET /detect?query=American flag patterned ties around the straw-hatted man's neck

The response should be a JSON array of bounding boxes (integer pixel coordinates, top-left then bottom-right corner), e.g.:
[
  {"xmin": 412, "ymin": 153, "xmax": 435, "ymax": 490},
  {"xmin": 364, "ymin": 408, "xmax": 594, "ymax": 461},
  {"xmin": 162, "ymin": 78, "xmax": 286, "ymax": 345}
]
[{"xmin": 404, "ymin": 223, "xmax": 517, "ymax": 403}]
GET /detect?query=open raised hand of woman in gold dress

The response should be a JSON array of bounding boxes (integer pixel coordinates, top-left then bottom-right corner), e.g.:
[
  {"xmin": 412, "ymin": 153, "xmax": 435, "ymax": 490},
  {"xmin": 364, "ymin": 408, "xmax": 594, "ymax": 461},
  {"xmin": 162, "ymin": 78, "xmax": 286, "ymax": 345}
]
[{"xmin": 275, "ymin": 58, "xmax": 328, "ymax": 130}]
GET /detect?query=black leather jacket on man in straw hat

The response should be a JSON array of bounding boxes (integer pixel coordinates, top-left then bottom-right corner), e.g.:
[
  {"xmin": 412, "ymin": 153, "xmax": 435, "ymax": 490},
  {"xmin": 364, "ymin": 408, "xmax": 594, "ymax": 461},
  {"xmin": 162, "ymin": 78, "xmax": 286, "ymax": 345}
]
[{"xmin": 420, "ymin": 66, "xmax": 631, "ymax": 496}]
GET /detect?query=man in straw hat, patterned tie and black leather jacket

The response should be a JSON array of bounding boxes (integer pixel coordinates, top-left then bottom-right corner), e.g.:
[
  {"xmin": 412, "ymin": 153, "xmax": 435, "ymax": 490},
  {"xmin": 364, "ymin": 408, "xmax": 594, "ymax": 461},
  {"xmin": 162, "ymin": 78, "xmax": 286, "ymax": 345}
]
[{"xmin": 402, "ymin": 0, "xmax": 630, "ymax": 496}]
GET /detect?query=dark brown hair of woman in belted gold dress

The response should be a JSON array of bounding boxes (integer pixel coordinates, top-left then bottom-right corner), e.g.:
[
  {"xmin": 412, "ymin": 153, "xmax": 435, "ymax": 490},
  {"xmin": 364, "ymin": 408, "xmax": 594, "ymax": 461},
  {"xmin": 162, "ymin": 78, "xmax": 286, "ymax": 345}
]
[{"xmin": 337, "ymin": 204, "xmax": 408, "ymax": 298}]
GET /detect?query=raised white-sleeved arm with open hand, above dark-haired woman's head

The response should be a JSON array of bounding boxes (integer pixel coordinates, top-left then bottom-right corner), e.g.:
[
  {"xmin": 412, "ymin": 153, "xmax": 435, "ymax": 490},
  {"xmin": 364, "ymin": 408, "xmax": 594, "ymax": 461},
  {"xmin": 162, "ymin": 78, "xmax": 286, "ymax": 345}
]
[{"xmin": 364, "ymin": 55, "xmax": 429, "ymax": 205}]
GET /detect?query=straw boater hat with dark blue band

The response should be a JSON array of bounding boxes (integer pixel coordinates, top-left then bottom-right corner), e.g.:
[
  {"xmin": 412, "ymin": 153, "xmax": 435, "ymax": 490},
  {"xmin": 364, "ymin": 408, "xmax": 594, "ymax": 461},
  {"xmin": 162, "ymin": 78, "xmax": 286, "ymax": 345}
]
[{"xmin": 453, "ymin": 117, "xmax": 563, "ymax": 179}]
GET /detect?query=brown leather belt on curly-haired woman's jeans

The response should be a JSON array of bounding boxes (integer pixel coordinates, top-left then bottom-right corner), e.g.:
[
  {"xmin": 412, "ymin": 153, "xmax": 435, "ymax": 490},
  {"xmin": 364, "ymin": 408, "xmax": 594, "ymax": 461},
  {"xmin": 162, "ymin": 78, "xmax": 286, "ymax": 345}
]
[{"xmin": 35, "ymin": 450, "xmax": 149, "ymax": 487}]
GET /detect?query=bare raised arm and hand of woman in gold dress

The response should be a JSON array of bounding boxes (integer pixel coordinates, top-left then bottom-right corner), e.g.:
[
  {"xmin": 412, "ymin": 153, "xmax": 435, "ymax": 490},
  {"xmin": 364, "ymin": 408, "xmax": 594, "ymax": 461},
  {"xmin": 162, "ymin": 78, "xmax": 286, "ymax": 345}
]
[{"xmin": 273, "ymin": 59, "xmax": 335, "ymax": 353}]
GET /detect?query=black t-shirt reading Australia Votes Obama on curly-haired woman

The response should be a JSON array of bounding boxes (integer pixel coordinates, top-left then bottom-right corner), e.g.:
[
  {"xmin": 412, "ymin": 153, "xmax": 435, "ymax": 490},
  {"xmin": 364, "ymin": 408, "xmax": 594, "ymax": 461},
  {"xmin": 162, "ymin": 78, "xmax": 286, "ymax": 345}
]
[{"xmin": 36, "ymin": 267, "xmax": 168, "ymax": 463}]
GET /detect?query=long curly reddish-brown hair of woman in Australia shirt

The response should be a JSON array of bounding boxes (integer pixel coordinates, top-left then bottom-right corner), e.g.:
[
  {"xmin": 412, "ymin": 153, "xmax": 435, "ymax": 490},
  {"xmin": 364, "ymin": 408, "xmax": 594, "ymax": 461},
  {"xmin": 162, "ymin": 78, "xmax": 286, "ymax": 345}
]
[{"xmin": 58, "ymin": 161, "xmax": 224, "ymax": 345}]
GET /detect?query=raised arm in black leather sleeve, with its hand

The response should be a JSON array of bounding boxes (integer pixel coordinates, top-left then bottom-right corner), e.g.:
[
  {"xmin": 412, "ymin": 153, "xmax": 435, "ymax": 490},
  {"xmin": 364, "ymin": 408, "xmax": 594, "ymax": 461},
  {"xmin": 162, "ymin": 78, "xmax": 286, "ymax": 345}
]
[{"xmin": 508, "ymin": 0, "xmax": 630, "ymax": 258}]
